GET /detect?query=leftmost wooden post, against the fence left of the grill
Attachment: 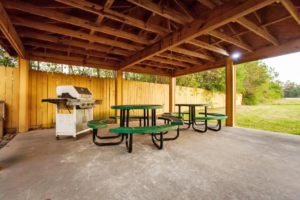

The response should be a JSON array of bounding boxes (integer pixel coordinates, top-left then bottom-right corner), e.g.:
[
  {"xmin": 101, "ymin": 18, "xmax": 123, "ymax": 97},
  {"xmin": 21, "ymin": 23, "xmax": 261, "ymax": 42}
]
[{"xmin": 18, "ymin": 57, "xmax": 29, "ymax": 133}]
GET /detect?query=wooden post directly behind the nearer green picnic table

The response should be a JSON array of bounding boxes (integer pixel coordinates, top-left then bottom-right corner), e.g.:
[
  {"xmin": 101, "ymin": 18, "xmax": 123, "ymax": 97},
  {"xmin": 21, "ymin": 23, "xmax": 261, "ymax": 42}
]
[{"xmin": 115, "ymin": 71, "xmax": 123, "ymax": 124}]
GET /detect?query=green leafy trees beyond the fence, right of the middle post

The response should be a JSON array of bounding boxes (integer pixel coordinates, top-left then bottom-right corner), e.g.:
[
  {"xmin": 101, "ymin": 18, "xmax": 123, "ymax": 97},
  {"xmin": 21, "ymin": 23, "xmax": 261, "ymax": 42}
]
[{"xmin": 124, "ymin": 61, "xmax": 284, "ymax": 105}]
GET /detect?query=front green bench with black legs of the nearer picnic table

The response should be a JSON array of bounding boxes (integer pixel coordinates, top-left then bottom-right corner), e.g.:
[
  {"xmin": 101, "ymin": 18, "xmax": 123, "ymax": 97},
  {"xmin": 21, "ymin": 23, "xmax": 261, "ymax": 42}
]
[{"xmin": 109, "ymin": 124, "xmax": 178, "ymax": 153}]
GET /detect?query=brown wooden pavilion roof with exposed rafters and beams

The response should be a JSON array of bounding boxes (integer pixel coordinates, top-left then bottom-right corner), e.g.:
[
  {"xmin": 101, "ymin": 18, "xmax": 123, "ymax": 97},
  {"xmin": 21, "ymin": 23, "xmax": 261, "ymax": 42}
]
[{"xmin": 0, "ymin": 0, "xmax": 300, "ymax": 77}]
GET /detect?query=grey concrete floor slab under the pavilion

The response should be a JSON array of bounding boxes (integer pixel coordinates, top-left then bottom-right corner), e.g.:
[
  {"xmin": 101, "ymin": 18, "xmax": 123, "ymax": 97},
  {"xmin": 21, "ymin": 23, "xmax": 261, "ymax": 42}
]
[{"xmin": 0, "ymin": 120, "xmax": 300, "ymax": 200}]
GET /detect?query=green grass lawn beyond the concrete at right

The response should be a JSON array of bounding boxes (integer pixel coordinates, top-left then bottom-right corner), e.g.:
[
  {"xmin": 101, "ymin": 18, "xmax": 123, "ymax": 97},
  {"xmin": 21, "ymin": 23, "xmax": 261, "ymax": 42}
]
[{"xmin": 195, "ymin": 100, "xmax": 300, "ymax": 135}]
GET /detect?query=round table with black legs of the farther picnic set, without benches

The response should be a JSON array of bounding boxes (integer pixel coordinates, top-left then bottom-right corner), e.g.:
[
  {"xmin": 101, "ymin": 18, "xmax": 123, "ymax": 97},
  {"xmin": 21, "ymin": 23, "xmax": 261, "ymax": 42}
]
[{"xmin": 175, "ymin": 104, "xmax": 211, "ymax": 132}]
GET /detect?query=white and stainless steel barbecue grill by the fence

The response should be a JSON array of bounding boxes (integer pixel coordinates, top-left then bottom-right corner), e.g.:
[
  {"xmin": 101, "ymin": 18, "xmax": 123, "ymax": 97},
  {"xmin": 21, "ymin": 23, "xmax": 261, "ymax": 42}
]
[{"xmin": 42, "ymin": 85, "xmax": 102, "ymax": 140}]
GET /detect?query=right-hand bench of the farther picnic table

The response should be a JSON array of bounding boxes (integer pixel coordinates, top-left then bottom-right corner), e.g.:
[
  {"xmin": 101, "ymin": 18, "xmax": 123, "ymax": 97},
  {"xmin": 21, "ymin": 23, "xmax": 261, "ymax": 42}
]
[{"xmin": 195, "ymin": 112, "xmax": 227, "ymax": 131}]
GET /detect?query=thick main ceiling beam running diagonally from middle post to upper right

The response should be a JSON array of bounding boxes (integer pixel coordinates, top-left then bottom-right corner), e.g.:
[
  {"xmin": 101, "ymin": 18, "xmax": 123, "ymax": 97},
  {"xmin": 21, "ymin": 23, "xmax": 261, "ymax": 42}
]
[{"xmin": 119, "ymin": 0, "xmax": 276, "ymax": 70}]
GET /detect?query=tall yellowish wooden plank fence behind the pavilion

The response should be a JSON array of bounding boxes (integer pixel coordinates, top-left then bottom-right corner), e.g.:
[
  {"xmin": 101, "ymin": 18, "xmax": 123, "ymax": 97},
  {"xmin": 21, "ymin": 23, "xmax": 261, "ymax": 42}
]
[{"xmin": 0, "ymin": 67, "xmax": 242, "ymax": 132}]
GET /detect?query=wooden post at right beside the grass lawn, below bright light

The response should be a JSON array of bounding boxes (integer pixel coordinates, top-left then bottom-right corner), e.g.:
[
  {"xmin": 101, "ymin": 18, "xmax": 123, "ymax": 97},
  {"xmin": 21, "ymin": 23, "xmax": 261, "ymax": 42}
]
[{"xmin": 226, "ymin": 58, "xmax": 236, "ymax": 126}]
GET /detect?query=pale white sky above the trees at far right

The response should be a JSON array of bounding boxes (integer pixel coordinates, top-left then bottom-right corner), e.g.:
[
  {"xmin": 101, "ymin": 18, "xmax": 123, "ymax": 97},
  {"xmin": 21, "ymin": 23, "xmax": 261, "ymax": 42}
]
[{"xmin": 262, "ymin": 53, "xmax": 300, "ymax": 84}]
